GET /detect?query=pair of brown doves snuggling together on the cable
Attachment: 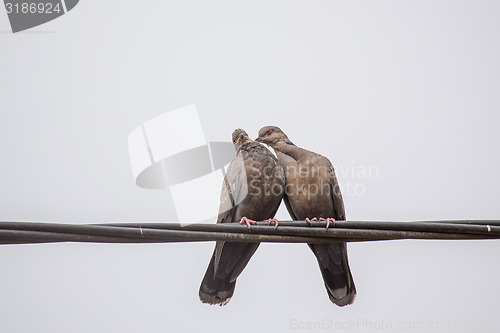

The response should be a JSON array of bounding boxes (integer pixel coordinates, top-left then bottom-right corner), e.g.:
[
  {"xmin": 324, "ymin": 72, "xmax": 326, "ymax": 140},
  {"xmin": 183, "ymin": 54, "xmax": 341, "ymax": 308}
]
[{"xmin": 199, "ymin": 126, "xmax": 356, "ymax": 306}]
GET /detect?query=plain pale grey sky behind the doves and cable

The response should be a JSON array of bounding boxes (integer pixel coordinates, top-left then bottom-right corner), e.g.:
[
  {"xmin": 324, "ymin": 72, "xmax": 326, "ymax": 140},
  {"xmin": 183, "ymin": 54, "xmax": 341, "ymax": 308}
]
[{"xmin": 0, "ymin": 0, "xmax": 500, "ymax": 332}]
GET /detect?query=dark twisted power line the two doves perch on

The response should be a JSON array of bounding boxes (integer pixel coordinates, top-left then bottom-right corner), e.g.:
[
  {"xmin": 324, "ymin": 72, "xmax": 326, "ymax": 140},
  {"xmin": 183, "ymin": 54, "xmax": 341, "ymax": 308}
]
[{"xmin": 0, "ymin": 220, "xmax": 500, "ymax": 244}]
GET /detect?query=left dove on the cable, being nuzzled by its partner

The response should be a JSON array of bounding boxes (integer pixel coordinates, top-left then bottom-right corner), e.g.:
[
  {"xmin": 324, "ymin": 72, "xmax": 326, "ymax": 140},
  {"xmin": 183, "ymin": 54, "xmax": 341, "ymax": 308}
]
[{"xmin": 199, "ymin": 129, "xmax": 285, "ymax": 306}]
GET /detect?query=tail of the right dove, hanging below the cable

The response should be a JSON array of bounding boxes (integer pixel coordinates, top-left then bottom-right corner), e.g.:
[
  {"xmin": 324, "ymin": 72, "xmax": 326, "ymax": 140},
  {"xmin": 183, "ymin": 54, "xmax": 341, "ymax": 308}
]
[{"xmin": 309, "ymin": 243, "xmax": 356, "ymax": 306}]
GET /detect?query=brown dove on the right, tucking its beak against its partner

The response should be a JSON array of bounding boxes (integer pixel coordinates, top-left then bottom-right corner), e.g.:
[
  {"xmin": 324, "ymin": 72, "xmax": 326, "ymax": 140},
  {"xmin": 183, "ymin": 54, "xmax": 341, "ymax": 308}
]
[{"xmin": 255, "ymin": 126, "xmax": 356, "ymax": 306}]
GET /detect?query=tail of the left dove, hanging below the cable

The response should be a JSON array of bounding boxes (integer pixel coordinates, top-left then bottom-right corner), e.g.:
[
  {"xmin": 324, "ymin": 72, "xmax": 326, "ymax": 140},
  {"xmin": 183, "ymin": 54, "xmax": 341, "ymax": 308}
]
[{"xmin": 199, "ymin": 242, "xmax": 259, "ymax": 306}]
